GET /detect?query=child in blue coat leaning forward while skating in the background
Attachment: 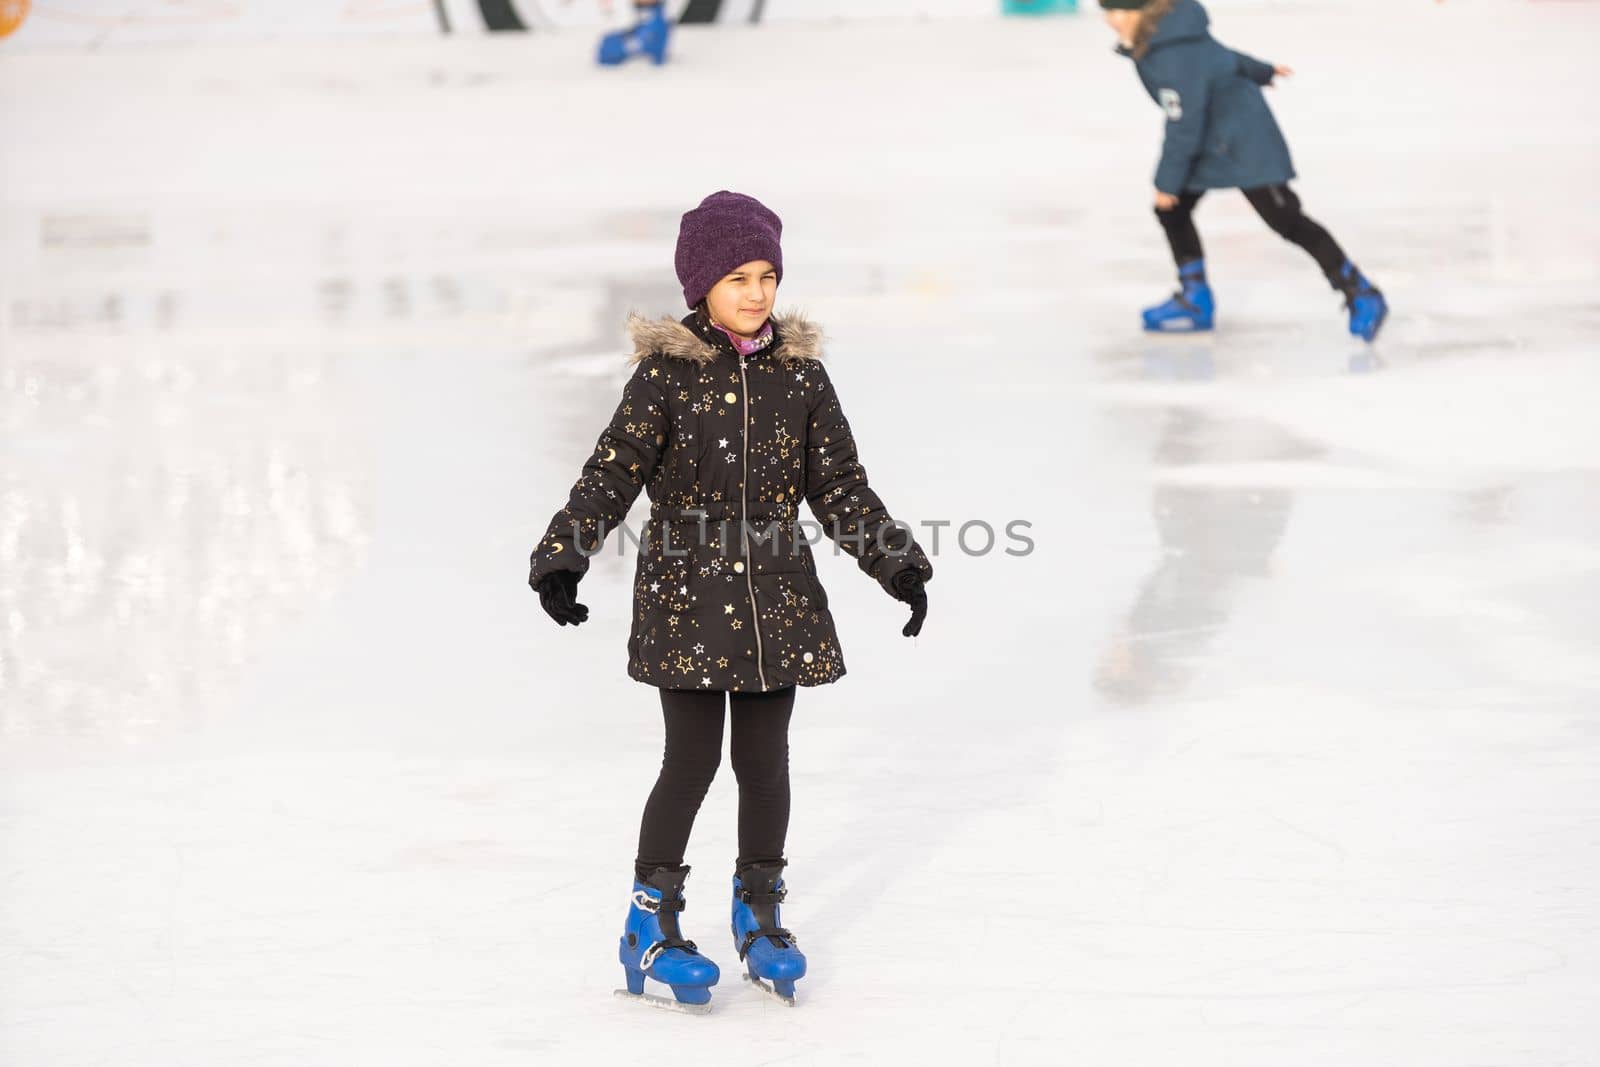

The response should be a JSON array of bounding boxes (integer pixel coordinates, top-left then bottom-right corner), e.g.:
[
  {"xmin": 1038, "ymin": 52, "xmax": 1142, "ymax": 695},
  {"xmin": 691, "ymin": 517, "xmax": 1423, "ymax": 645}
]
[{"xmin": 1101, "ymin": 0, "xmax": 1389, "ymax": 341}]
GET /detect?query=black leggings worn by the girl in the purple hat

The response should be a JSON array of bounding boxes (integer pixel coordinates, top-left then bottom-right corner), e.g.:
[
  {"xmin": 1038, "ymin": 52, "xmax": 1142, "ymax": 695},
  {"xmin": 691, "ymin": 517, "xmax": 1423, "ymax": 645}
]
[{"xmin": 635, "ymin": 686, "xmax": 795, "ymax": 878}]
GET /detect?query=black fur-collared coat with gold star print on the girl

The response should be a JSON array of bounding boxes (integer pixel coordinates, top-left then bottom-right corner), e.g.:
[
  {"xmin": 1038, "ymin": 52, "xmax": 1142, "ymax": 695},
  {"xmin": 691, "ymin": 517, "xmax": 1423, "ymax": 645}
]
[{"xmin": 531, "ymin": 314, "xmax": 933, "ymax": 691}]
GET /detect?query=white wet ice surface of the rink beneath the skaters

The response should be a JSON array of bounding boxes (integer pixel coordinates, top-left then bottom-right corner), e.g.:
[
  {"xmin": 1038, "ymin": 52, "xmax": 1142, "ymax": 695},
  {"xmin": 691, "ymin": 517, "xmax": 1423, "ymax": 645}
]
[{"xmin": 0, "ymin": 0, "xmax": 1600, "ymax": 1067}]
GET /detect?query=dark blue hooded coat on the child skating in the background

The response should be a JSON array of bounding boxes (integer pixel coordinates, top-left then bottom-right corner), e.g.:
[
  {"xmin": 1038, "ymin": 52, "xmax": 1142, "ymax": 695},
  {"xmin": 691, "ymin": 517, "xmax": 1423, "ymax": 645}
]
[{"xmin": 1117, "ymin": 0, "xmax": 1294, "ymax": 195}]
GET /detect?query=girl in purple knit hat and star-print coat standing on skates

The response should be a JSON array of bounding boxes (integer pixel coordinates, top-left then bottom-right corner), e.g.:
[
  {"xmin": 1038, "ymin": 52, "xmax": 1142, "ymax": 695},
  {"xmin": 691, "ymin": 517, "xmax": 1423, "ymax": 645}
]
[{"xmin": 528, "ymin": 192, "xmax": 933, "ymax": 1011}]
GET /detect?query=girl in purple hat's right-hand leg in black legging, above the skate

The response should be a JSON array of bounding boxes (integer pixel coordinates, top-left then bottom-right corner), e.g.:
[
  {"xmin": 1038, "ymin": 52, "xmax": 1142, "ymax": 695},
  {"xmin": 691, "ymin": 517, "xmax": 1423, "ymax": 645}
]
[{"xmin": 728, "ymin": 686, "xmax": 795, "ymax": 867}]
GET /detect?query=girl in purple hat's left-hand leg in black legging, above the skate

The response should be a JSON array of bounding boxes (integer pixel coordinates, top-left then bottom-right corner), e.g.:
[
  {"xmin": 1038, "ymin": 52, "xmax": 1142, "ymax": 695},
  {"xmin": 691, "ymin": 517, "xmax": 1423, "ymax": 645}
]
[{"xmin": 634, "ymin": 689, "xmax": 726, "ymax": 880}]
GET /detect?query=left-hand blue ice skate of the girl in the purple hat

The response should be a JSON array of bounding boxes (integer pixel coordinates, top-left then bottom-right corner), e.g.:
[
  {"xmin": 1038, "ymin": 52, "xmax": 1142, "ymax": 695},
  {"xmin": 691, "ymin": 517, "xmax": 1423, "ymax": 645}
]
[{"xmin": 616, "ymin": 867, "xmax": 722, "ymax": 1014}]
